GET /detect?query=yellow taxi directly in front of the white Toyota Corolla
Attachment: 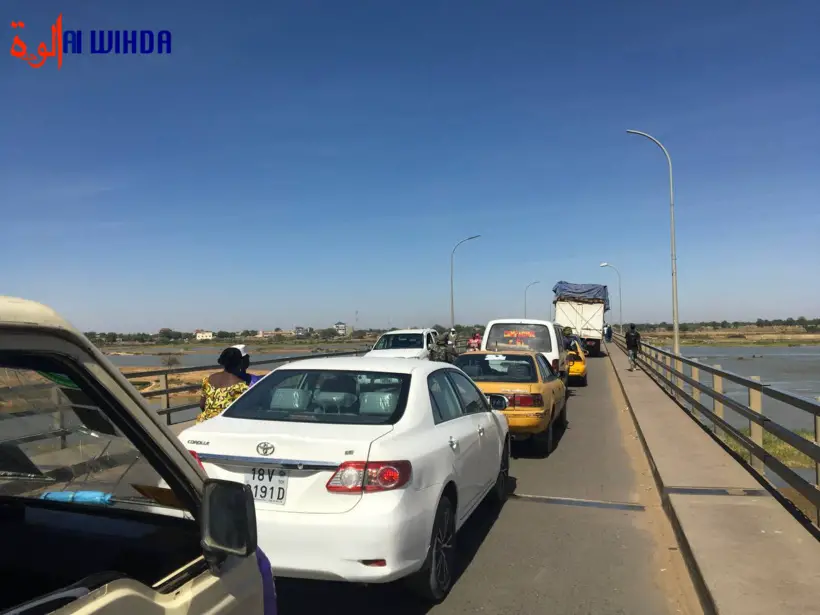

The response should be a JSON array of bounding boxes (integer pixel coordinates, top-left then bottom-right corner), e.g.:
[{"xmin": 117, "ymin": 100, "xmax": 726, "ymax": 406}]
[{"xmin": 455, "ymin": 350, "xmax": 567, "ymax": 455}]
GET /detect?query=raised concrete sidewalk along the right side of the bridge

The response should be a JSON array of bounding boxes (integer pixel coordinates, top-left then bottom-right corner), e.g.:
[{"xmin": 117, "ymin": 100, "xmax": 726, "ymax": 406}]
[{"xmin": 607, "ymin": 344, "xmax": 820, "ymax": 615}]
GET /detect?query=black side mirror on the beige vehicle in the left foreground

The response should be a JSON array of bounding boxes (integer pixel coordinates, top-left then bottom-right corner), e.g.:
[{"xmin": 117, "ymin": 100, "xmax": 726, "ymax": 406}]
[{"xmin": 199, "ymin": 478, "xmax": 257, "ymax": 568}]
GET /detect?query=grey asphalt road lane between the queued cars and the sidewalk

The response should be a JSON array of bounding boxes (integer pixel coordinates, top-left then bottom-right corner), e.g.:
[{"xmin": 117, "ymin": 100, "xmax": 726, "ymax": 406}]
[{"xmin": 277, "ymin": 357, "xmax": 702, "ymax": 615}]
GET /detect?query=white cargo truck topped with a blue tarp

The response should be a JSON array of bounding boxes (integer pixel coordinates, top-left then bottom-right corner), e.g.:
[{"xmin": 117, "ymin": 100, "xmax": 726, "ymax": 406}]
[{"xmin": 552, "ymin": 281, "xmax": 609, "ymax": 356}]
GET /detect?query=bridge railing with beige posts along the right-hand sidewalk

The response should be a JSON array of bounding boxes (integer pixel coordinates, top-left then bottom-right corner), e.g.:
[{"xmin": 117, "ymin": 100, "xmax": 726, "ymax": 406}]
[{"xmin": 613, "ymin": 334, "xmax": 820, "ymax": 524}]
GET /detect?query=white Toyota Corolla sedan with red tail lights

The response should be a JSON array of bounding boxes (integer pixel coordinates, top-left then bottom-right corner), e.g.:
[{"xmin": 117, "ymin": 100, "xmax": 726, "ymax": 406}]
[{"xmin": 180, "ymin": 357, "xmax": 510, "ymax": 602}]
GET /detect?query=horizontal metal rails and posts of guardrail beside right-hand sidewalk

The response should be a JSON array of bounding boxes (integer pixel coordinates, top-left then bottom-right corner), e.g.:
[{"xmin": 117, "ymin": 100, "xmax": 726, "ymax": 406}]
[{"xmin": 613, "ymin": 333, "xmax": 820, "ymax": 524}]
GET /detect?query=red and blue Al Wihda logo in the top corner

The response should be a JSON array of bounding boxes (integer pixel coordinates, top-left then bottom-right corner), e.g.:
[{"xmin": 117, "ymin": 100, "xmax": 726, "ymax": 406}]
[{"xmin": 10, "ymin": 13, "xmax": 171, "ymax": 70}]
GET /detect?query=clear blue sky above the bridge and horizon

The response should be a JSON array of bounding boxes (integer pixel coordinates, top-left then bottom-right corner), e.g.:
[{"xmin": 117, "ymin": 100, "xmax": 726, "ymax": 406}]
[{"xmin": 0, "ymin": 0, "xmax": 820, "ymax": 331}]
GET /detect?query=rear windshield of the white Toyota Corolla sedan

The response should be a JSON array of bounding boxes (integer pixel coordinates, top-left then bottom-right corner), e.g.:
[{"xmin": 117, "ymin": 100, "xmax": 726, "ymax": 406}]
[{"xmin": 223, "ymin": 369, "xmax": 410, "ymax": 425}]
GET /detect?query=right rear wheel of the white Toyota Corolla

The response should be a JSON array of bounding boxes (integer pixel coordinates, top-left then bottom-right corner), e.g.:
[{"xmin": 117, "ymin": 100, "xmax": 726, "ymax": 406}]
[{"xmin": 409, "ymin": 495, "xmax": 456, "ymax": 604}]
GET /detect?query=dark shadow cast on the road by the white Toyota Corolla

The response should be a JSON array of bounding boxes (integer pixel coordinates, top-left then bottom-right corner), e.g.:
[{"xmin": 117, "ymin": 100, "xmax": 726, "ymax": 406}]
[{"xmin": 276, "ymin": 498, "xmax": 502, "ymax": 615}]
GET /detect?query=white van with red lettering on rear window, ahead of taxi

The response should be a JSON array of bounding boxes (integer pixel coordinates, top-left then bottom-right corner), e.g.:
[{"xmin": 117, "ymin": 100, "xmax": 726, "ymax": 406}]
[{"xmin": 481, "ymin": 318, "xmax": 568, "ymax": 384}]
